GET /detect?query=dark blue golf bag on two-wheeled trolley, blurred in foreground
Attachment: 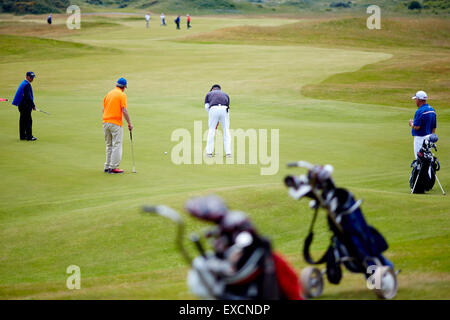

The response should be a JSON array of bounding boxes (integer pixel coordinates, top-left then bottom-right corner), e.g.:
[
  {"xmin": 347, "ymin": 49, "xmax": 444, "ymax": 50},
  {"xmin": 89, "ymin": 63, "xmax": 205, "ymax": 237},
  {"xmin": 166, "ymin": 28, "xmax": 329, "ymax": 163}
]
[{"xmin": 285, "ymin": 161, "xmax": 398, "ymax": 299}]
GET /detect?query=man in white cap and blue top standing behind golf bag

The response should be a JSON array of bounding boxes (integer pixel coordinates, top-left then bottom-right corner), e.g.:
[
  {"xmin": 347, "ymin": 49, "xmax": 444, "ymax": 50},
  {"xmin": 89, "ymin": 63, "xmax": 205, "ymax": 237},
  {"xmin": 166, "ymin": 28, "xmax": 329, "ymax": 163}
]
[{"xmin": 409, "ymin": 91, "xmax": 436, "ymax": 159}]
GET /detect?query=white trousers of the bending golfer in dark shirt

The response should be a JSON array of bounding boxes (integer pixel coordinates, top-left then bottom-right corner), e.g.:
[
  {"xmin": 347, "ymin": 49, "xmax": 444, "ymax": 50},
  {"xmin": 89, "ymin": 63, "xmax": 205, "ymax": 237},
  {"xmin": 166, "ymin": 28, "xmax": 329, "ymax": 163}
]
[{"xmin": 206, "ymin": 106, "xmax": 231, "ymax": 154}]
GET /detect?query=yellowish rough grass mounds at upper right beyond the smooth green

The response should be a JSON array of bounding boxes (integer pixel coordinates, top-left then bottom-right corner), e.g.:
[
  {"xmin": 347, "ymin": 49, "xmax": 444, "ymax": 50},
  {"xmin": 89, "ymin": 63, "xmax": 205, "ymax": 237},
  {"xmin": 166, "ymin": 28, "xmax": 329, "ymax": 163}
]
[{"xmin": 181, "ymin": 18, "xmax": 450, "ymax": 109}]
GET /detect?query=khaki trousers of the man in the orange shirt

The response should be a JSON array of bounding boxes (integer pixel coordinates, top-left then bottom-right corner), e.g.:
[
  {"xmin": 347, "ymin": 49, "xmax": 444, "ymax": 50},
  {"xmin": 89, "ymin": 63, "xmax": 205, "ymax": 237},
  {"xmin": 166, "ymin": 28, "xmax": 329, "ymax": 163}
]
[{"xmin": 103, "ymin": 122, "xmax": 123, "ymax": 169}]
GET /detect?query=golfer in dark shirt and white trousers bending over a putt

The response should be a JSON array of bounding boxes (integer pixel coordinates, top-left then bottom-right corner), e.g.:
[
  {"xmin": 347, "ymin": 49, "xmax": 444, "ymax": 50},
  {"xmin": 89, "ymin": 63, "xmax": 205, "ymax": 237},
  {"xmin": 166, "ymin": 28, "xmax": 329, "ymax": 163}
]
[{"xmin": 205, "ymin": 84, "xmax": 231, "ymax": 158}]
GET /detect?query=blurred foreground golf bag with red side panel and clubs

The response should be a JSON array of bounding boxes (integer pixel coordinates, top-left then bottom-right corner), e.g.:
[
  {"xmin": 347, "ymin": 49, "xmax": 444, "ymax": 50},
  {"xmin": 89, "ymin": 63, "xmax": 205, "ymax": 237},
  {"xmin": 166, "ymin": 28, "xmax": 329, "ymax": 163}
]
[{"xmin": 186, "ymin": 196, "xmax": 301, "ymax": 300}]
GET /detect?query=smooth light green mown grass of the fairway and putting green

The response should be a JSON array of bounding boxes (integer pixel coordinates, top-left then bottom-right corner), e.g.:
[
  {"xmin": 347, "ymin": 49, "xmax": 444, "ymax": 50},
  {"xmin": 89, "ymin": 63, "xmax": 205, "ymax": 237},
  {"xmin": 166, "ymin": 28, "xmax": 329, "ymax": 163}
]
[{"xmin": 0, "ymin": 13, "xmax": 450, "ymax": 299}]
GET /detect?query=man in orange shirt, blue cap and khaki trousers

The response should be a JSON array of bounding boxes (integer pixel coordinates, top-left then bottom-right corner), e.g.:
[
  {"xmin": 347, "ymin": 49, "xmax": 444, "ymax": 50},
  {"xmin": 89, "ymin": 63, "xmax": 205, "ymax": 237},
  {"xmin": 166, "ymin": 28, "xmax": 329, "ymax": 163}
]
[{"xmin": 103, "ymin": 78, "xmax": 133, "ymax": 173}]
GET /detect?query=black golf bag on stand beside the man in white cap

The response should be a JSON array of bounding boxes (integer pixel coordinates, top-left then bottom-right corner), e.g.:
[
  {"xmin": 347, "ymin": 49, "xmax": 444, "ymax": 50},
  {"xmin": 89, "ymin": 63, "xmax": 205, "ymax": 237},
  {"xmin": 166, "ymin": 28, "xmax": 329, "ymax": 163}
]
[{"xmin": 409, "ymin": 134, "xmax": 441, "ymax": 193}]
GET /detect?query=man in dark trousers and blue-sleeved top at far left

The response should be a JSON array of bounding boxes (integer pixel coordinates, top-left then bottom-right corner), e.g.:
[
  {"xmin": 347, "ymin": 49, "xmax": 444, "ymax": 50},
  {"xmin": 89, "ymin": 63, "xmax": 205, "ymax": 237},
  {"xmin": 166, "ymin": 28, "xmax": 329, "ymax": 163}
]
[{"xmin": 12, "ymin": 71, "xmax": 37, "ymax": 141}]
